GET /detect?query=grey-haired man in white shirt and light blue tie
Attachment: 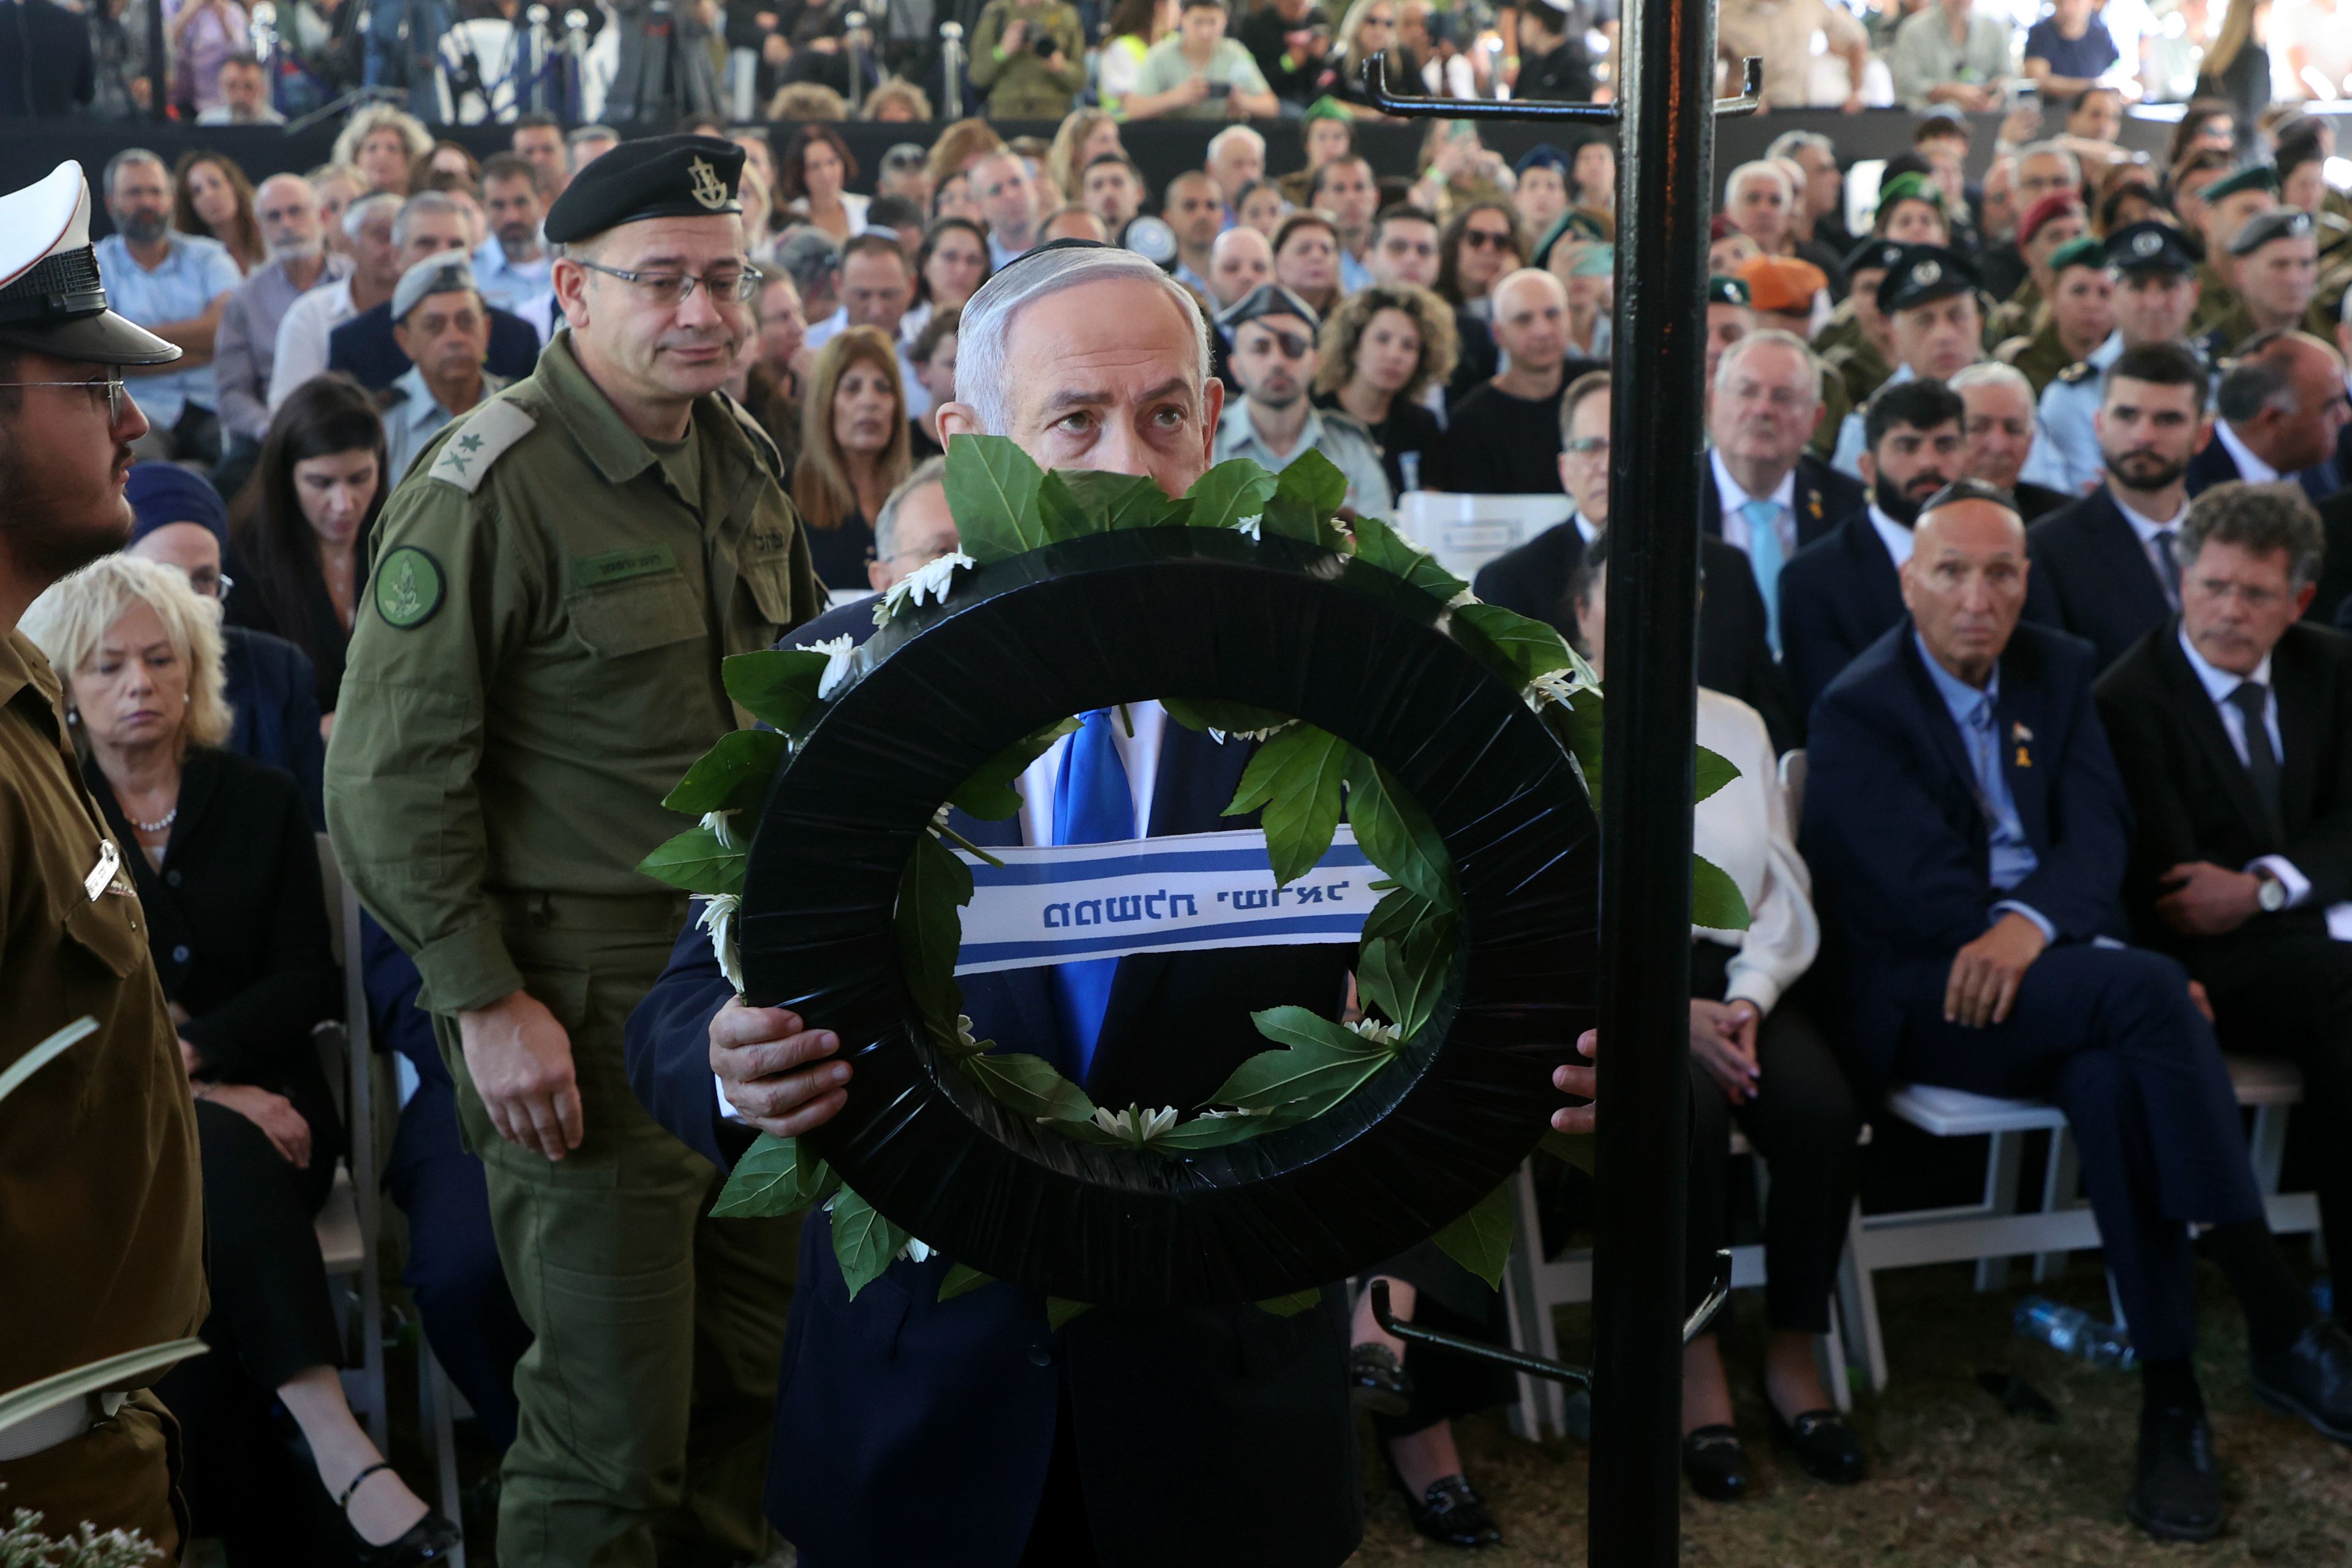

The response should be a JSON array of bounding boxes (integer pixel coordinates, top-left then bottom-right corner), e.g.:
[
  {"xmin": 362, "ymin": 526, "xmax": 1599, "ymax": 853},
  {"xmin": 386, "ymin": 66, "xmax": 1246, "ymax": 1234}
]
[{"xmin": 1698, "ymin": 329, "xmax": 1868, "ymax": 658}]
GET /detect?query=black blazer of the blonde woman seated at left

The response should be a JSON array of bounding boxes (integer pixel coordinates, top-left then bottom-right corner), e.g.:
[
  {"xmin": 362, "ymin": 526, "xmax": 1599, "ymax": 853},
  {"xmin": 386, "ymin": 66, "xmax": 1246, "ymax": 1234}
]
[{"xmin": 82, "ymin": 745, "xmax": 344, "ymax": 1142}]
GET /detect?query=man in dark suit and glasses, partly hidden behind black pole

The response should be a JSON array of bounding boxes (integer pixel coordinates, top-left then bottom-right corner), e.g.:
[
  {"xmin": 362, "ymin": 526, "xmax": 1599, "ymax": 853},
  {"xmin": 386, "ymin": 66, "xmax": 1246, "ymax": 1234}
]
[{"xmin": 1470, "ymin": 369, "xmax": 1787, "ymax": 750}]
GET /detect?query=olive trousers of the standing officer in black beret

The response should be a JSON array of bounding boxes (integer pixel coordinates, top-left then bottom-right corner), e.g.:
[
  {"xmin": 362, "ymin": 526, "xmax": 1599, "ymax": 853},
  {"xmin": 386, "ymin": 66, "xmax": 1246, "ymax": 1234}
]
[{"xmin": 435, "ymin": 900, "xmax": 800, "ymax": 1568}]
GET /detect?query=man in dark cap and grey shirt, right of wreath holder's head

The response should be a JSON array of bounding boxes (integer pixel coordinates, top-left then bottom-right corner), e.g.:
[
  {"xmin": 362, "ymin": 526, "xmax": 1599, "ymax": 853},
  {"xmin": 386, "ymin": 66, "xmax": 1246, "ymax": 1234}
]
[{"xmin": 1216, "ymin": 282, "xmax": 1392, "ymax": 517}]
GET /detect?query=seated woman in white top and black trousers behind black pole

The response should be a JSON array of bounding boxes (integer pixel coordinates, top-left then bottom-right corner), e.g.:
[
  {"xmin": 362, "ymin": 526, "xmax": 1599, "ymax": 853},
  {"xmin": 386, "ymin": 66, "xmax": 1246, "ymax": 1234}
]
[{"xmin": 1569, "ymin": 533, "xmax": 1865, "ymax": 1502}]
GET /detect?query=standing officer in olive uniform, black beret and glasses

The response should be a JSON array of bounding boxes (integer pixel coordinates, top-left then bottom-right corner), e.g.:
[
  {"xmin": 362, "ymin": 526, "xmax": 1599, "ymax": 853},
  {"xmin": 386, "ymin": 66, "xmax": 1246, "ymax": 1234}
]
[{"xmin": 327, "ymin": 137, "xmax": 823, "ymax": 1568}]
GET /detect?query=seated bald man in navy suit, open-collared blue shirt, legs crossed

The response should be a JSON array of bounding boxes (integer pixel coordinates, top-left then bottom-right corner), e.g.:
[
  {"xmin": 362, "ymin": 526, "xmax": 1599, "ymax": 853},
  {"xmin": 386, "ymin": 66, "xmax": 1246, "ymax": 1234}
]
[{"xmin": 1804, "ymin": 482, "xmax": 2352, "ymax": 1540}]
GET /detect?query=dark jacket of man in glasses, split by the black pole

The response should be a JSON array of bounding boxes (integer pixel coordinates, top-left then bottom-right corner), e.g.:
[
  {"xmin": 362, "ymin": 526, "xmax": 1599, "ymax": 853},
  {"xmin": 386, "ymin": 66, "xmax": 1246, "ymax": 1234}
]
[{"xmin": 1470, "ymin": 519, "xmax": 1801, "ymax": 752}]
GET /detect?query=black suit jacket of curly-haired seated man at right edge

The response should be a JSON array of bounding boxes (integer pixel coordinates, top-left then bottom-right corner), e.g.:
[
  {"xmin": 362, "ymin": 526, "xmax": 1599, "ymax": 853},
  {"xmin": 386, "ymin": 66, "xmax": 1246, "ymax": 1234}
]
[{"xmin": 2098, "ymin": 618, "xmax": 2352, "ymax": 973}]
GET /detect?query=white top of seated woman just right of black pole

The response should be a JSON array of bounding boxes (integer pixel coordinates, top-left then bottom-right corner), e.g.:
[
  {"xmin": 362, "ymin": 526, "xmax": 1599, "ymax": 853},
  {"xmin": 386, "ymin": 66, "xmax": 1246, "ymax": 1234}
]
[{"xmin": 1694, "ymin": 687, "xmax": 1820, "ymax": 1013}]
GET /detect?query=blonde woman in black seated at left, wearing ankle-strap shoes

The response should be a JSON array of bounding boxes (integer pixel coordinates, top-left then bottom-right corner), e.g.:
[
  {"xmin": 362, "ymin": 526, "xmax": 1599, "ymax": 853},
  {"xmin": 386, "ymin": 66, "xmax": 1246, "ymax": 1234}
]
[{"xmin": 23, "ymin": 555, "xmax": 459, "ymax": 1563}]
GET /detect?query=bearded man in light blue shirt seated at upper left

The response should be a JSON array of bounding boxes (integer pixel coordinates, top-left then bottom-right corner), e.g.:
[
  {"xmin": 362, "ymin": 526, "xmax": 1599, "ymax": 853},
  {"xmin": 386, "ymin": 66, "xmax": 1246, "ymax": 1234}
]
[{"xmin": 96, "ymin": 148, "xmax": 238, "ymax": 463}]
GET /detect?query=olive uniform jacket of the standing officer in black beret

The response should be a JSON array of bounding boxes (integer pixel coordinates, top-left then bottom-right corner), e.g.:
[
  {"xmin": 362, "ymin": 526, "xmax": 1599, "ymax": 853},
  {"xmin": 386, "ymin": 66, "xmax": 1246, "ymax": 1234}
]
[{"xmin": 327, "ymin": 331, "xmax": 826, "ymax": 1013}]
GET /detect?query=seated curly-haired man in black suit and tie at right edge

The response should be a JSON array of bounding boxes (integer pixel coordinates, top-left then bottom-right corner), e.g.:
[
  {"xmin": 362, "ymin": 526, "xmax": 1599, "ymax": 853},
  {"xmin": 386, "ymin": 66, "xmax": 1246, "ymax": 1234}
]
[{"xmin": 2098, "ymin": 484, "xmax": 2352, "ymax": 1321}]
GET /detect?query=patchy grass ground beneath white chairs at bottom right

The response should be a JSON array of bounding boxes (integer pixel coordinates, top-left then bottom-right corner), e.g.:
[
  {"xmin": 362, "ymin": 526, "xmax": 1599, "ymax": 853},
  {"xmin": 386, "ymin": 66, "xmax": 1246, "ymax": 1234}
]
[{"xmin": 1355, "ymin": 1260, "xmax": 2352, "ymax": 1568}]
